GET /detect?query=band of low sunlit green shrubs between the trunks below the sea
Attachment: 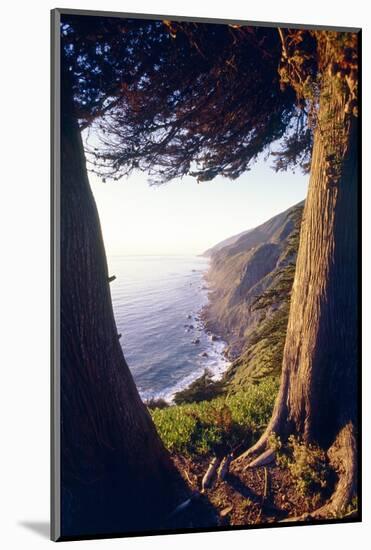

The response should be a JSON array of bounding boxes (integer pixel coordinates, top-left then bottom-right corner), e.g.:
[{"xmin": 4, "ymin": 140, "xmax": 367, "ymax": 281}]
[{"xmin": 150, "ymin": 378, "xmax": 278, "ymax": 455}]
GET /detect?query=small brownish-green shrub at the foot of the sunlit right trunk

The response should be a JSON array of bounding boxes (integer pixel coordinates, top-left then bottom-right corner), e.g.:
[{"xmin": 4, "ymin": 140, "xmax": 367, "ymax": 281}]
[{"xmin": 270, "ymin": 434, "xmax": 331, "ymax": 496}]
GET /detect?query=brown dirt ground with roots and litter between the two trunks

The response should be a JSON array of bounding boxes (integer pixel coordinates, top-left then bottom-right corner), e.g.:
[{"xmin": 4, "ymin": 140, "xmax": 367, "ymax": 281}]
[{"xmin": 167, "ymin": 455, "xmax": 330, "ymax": 528}]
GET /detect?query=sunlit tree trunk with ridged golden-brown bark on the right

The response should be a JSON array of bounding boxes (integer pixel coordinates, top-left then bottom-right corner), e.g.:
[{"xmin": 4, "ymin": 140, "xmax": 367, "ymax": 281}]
[{"xmin": 240, "ymin": 36, "xmax": 358, "ymax": 516}]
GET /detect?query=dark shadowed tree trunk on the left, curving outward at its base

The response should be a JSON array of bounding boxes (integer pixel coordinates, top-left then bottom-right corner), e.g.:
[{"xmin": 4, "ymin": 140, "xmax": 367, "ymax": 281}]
[{"xmin": 60, "ymin": 62, "xmax": 185, "ymax": 536}]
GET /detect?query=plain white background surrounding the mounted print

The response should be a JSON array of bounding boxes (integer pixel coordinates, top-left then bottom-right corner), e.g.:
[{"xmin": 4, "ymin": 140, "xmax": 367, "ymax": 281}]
[{"xmin": 0, "ymin": 0, "xmax": 371, "ymax": 550}]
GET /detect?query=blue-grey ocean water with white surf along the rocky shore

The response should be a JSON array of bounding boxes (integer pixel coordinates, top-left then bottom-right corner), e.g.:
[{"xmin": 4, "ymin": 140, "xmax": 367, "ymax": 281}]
[{"xmin": 108, "ymin": 256, "xmax": 229, "ymax": 401}]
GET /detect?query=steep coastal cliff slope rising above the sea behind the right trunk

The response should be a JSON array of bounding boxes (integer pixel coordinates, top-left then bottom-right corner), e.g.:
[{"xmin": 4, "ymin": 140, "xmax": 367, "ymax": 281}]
[{"xmin": 203, "ymin": 203, "xmax": 304, "ymax": 384}]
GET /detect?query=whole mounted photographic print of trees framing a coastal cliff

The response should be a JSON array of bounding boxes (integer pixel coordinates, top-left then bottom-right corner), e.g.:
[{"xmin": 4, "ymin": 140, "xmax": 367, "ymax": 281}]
[{"xmin": 52, "ymin": 9, "xmax": 361, "ymax": 540}]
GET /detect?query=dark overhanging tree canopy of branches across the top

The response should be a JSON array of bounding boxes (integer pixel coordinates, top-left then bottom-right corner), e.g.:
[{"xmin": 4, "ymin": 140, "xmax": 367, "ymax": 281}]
[{"xmin": 62, "ymin": 16, "xmax": 315, "ymax": 183}]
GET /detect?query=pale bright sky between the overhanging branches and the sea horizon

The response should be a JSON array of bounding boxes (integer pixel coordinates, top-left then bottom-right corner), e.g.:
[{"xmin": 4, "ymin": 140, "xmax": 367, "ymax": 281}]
[{"xmin": 89, "ymin": 157, "xmax": 309, "ymax": 256}]
